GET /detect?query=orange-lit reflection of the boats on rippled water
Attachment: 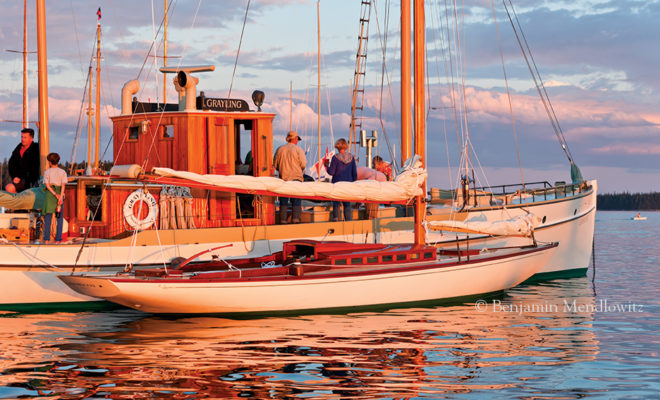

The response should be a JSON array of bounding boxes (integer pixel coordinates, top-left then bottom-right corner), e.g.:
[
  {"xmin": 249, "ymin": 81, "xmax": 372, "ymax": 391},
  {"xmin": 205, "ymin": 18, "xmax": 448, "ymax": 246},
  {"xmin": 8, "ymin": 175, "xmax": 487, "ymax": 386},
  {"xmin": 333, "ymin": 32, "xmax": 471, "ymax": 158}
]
[{"xmin": 0, "ymin": 278, "xmax": 599, "ymax": 398}]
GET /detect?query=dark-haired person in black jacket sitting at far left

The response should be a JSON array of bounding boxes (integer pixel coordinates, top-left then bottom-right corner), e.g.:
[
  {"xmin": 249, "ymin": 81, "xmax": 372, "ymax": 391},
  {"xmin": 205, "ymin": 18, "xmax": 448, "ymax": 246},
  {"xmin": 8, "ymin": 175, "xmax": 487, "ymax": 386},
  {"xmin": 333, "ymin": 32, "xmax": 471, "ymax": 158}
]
[{"xmin": 5, "ymin": 128, "xmax": 40, "ymax": 193}]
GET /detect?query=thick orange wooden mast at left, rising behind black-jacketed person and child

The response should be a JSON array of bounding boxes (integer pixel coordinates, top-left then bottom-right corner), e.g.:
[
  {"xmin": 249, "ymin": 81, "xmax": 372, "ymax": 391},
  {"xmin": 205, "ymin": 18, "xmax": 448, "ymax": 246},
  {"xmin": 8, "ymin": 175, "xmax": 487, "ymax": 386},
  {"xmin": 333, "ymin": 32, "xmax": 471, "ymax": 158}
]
[{"xmin": 36, "ymin": 0, "xmax": 50, "ymax": 173}]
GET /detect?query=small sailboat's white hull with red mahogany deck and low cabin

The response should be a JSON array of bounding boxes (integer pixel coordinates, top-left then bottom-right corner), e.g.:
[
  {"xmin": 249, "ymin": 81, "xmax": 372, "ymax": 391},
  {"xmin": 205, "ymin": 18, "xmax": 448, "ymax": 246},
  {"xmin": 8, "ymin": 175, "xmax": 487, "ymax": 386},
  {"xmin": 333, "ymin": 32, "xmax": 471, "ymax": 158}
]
[{"xmin": 59, "ymin": 240, "xmax": 557, "ymax": 314}]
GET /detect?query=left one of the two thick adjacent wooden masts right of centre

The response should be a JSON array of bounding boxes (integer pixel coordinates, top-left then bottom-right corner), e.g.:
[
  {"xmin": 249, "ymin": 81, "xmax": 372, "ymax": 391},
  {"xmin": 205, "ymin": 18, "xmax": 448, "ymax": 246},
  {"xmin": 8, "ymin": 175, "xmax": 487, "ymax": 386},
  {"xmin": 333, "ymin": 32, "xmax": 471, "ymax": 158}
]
[{"xmin": 401, "ymin": 0, "xmax": 412, "ymax": 165}]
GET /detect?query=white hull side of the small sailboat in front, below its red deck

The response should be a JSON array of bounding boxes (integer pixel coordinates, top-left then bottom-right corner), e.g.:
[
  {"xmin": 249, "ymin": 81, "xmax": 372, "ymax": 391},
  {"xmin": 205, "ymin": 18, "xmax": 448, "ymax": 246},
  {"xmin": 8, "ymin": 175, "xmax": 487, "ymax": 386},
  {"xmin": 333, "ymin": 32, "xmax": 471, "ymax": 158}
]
[{"xmin": 60, "ymin": 248, "xmax": 556, "ymax": 314}]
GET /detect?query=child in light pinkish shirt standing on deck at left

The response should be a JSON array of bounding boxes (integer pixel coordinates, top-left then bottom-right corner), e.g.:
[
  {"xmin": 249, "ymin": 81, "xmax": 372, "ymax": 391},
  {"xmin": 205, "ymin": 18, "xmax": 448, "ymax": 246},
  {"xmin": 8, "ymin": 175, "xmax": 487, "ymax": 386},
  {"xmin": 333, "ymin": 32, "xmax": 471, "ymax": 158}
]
[{"xmin": 43, "ymin": 153, "xmax": 67, "ymax": 243}]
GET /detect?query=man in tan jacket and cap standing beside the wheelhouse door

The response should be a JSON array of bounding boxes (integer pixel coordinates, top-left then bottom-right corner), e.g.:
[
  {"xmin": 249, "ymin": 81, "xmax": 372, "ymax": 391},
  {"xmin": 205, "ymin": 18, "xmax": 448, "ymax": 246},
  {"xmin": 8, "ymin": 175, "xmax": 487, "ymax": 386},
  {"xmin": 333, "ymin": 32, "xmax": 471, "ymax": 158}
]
[{"xmin": 273, "ymin": 131, "xmax": 307, "ymax": 224}]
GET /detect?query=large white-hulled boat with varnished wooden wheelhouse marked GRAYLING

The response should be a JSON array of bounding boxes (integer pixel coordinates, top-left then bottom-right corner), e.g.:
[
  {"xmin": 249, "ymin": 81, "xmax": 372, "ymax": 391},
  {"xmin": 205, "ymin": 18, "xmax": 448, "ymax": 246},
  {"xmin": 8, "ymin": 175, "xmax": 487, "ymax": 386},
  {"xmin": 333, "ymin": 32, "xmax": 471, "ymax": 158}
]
[{"xmin": 0, "ymin": 0, "xmax": 596, "ymax": 310}]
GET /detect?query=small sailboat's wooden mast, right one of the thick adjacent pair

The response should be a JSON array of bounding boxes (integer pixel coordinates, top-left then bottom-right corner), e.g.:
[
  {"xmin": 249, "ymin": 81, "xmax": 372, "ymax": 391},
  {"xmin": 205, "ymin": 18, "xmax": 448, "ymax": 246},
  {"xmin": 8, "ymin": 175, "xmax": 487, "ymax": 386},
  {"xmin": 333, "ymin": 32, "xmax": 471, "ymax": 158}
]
[{"xmin": 414, "ymin": 0, "xmax": 426, "ymax": 245}]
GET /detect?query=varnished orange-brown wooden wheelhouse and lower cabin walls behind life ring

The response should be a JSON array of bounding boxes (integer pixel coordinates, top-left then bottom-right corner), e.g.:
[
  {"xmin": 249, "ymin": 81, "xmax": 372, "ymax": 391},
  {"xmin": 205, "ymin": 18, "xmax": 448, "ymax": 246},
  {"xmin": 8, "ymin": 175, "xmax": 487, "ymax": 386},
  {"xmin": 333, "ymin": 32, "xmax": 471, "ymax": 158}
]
[{"xmin": 60, "ymin": 111, "xmax": 275, "ymax": 238}]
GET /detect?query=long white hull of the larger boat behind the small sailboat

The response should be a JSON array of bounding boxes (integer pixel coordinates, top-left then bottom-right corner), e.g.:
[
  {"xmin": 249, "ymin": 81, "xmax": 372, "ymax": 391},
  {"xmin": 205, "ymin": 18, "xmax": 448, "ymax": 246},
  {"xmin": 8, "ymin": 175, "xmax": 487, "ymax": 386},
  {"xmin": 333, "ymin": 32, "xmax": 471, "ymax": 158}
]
[{"xmin": 0, "ymin": 181, "xmax": 597, "ymax": 307}]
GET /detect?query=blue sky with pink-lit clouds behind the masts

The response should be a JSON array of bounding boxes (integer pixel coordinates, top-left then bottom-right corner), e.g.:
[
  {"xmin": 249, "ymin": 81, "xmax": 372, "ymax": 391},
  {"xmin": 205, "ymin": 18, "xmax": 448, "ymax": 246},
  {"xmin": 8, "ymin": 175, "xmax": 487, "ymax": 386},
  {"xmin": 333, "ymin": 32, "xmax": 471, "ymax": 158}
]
[{"xmin": 0, "ymin": 0, "xmax": 660, "ymax": 193}]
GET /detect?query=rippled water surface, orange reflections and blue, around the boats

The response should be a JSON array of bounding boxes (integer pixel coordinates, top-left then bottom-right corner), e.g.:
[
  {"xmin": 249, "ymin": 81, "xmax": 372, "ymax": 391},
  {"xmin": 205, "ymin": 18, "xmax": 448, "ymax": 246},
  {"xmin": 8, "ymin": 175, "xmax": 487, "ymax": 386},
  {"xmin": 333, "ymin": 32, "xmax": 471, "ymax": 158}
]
[{"xmin": 0, "ymin": 212, "xmax": 660, "ymax": 399}]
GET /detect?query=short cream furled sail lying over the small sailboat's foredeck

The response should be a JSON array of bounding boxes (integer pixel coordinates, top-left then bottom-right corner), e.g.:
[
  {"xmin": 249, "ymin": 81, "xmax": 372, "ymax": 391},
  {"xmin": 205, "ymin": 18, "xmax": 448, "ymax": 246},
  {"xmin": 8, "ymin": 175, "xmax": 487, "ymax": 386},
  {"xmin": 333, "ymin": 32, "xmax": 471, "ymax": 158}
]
[{"xmin": 427, "ymin": 213, "xmax": 541, "ymax": 237}]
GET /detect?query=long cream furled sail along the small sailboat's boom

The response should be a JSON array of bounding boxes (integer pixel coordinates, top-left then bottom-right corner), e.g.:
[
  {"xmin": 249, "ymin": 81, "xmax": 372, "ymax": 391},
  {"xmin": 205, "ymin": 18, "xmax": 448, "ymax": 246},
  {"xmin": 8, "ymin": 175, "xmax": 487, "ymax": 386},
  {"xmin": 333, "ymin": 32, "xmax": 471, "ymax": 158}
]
[{"xmin": 152, "ymin": 158, "xmax": 426, "ymax": 203}]
